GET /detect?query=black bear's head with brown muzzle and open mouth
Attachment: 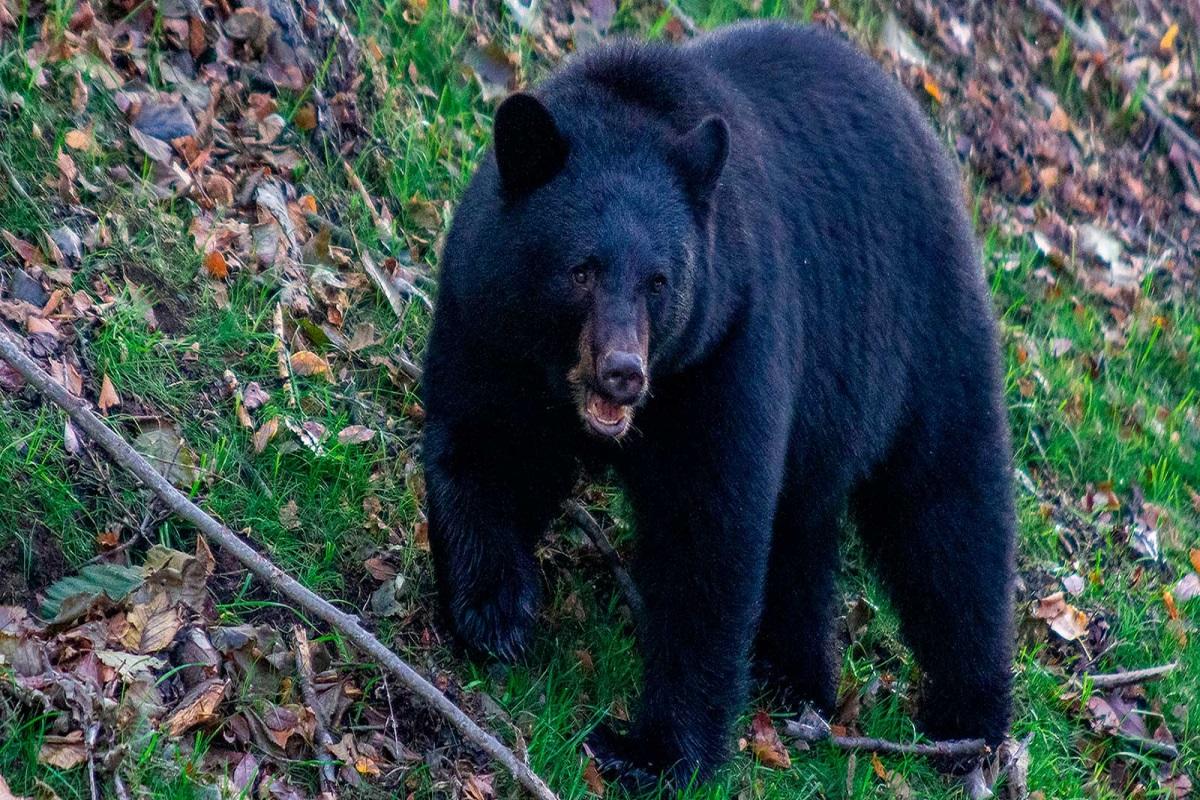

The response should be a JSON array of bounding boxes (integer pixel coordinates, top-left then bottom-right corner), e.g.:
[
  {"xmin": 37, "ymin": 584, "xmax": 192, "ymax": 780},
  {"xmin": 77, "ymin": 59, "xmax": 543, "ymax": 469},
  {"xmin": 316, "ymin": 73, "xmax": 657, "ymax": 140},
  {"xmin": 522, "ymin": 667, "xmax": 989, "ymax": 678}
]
[{"xmin": 443, "ymin": 94, "xmax": 730, "ymax": 439}]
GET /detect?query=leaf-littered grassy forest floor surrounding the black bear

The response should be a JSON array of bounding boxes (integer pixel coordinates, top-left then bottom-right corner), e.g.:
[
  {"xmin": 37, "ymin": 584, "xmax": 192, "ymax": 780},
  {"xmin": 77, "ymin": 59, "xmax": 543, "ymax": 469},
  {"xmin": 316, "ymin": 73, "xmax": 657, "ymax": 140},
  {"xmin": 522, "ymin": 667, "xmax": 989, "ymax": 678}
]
[{"xmin": 0, "ymin": 0, "xmax": 1200, "ymax": 800}]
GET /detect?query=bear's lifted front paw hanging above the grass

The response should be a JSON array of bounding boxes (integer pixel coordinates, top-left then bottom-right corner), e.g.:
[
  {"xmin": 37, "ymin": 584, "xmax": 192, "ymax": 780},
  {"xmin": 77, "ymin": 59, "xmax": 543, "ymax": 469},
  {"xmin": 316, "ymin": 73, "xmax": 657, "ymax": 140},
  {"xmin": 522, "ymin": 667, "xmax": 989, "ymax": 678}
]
[{"xmin": 450, "ymin": 570, "xmax": 541, "ymax": 661}]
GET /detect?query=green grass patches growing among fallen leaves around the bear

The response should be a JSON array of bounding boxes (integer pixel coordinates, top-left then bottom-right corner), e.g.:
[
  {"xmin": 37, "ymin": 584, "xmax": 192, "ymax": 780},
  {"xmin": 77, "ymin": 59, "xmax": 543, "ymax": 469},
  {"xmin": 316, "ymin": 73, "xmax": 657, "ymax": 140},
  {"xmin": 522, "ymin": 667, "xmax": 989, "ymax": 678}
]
[{"xmin": 0, "ymin": 0, "xmax": 1200, "ymax": 799}]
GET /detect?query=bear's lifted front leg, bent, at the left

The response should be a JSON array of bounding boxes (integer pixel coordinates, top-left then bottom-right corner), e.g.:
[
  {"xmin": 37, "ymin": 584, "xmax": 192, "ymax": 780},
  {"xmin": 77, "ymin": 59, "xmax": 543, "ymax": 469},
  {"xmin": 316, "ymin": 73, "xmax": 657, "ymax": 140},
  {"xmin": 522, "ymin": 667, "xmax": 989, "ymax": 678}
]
[{"xmin": 425, "ymin": 423, "xmax": 575, "ymax": 661}]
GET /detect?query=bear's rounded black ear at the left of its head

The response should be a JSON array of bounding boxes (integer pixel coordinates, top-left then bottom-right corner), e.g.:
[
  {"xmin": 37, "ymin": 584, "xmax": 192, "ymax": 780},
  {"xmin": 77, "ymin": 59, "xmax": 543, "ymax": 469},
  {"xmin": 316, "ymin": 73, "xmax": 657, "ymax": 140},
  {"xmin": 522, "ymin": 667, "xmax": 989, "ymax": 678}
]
[{"xmin": 493, "ymin": 92, "xmax": 568, "ymax": 197}]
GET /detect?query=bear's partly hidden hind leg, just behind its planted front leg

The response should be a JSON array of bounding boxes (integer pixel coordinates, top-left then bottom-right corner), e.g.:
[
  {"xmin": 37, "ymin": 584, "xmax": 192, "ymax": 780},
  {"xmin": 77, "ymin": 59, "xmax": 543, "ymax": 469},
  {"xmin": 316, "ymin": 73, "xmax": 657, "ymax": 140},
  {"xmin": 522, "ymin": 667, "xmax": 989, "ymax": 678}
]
[{"xmin": 755, "ymin": 492, "xmax": 840, "ymax": 715}]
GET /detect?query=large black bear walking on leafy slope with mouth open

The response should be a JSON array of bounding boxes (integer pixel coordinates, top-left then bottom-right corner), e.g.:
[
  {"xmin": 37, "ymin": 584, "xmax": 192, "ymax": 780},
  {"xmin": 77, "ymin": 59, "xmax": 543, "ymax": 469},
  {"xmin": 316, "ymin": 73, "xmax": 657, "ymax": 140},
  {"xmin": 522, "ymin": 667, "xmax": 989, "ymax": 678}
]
[{"xmin": 424, "ymin": 23, "xmax": 1014, "ymax": 782}]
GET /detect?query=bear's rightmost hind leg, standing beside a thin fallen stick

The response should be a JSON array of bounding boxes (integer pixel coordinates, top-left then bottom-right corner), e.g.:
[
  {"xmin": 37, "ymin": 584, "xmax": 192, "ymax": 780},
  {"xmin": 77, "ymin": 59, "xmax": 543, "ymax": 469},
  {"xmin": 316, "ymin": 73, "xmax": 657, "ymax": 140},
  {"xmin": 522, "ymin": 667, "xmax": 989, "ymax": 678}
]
[{"xmin": 854, "ymin": 412, "xmax": 1013, "ymax": 768}]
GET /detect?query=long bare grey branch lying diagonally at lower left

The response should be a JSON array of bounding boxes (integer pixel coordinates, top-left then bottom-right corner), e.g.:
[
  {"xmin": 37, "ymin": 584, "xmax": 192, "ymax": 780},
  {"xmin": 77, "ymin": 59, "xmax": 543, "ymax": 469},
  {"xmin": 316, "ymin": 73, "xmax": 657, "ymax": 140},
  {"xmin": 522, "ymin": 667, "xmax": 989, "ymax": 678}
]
[{"xmin": 0, "ymin": 330, "xmax": 557, "ymax": 800}]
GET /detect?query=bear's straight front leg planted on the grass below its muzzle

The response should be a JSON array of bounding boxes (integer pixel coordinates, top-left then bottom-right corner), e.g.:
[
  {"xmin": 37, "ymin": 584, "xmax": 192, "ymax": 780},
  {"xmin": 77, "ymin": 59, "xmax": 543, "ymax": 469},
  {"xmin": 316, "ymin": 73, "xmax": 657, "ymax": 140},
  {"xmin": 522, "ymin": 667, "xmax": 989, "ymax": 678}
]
[{"xmin": 588, "ymin": 400, "xmax": 785, "ymax": 788}]
